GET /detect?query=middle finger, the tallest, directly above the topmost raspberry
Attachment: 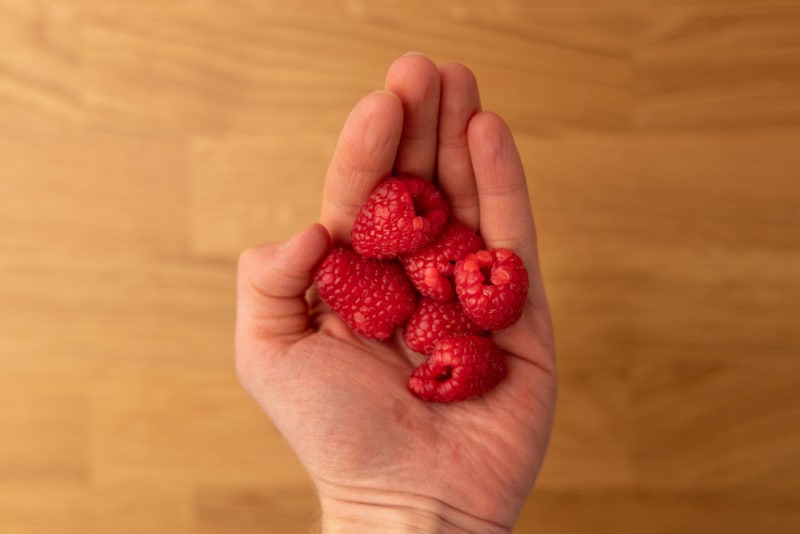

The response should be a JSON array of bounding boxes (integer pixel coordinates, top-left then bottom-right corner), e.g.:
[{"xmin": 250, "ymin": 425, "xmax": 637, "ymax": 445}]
[{"xmin": 386, "ymin": 53, "xmax": 440, "ymax": 180}]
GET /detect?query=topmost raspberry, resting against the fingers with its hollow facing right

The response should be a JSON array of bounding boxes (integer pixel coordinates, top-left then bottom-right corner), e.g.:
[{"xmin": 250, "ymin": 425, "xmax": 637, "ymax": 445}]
[{"xmin": 350, "ymin": 176, "xmax": 450, "ymax": 259}]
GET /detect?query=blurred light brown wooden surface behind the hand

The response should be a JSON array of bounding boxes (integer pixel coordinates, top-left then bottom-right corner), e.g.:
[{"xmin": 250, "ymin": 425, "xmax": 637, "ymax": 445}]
[{"xmin": 0, "ymin": 0, "xmax": 800, "ymax": 534}]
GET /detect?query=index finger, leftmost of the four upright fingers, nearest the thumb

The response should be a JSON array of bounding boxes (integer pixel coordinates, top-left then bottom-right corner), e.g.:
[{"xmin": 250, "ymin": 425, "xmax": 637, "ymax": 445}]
[{"xmin": 320, "ymin": 91, "xmax": 403, "ymax": 244}]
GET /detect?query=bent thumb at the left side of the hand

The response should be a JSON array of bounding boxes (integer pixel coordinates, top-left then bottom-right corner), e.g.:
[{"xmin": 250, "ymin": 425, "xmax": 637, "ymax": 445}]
[{"xmin": 236, "ymin": 224, "xmax": 330, "ymax": 352}]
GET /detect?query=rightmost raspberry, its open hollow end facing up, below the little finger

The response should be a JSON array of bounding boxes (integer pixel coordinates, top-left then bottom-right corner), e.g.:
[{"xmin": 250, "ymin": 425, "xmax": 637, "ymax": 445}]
[{"xmin": 454, "ymin": 248, "xmax": 528, "ymax": 330}]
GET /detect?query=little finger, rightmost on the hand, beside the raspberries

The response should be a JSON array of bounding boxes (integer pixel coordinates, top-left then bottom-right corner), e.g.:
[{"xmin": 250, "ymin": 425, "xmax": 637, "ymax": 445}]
[{"xmin": 467, "ymin": 112, "xmax": 547, "ymax": 318}]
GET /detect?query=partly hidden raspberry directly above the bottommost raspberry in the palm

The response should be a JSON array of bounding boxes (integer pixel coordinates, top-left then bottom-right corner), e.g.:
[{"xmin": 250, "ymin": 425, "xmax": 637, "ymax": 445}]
[{"xmin": 403, "ymin": 297, "xmax": 484, "ymax": 354}]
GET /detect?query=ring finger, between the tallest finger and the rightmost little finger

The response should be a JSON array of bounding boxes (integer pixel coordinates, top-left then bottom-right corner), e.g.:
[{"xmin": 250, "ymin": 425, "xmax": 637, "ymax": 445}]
[{"xmin": 437, "ymin": 63, "xmax": 481, "ymax": 228}]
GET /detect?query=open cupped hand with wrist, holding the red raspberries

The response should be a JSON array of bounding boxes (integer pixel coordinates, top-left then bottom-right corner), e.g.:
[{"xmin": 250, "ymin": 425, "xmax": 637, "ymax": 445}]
[{"xmin": 236, "ymin": 54, "xmax": 556, "ymax": 533}]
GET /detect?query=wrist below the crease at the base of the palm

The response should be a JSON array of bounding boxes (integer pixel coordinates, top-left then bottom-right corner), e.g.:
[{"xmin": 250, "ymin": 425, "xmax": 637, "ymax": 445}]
[{"xmin": 320, "ymin": 488, "xmax": 511, "ymax": 534}]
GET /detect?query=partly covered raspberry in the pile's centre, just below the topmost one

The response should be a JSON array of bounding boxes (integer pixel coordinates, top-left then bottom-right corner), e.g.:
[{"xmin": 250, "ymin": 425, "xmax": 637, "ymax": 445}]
[{"xmin": 400, "ymin": 221, "xmax": 484, "ymax": 300}]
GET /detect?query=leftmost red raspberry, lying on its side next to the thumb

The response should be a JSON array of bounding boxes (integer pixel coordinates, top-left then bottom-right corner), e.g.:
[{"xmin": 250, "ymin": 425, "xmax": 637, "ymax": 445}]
[{"xmin": 314, "ymin": 248, "xmax": 416, "ymax": 339}]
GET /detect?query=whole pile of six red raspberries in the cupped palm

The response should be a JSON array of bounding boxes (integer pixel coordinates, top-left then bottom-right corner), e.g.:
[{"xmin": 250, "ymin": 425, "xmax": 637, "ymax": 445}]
[{"xmin": 314, "ymin": 176, "xmax": 528, "ymax": 402}]
